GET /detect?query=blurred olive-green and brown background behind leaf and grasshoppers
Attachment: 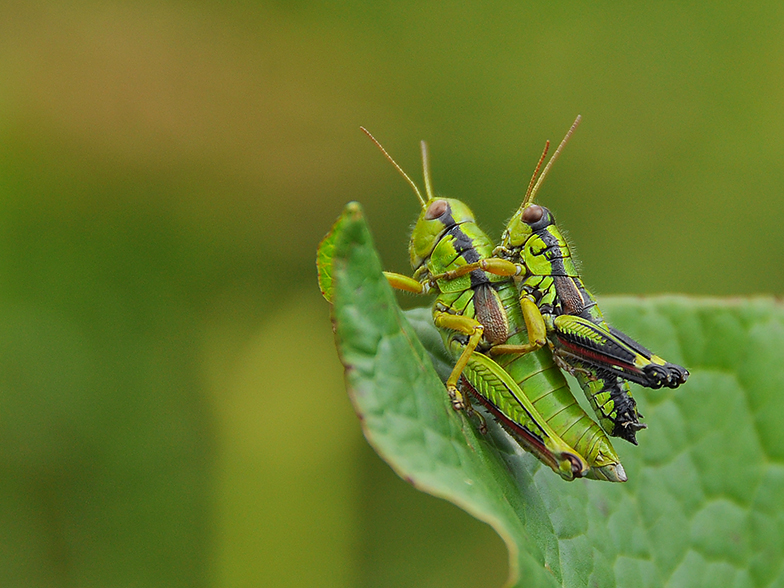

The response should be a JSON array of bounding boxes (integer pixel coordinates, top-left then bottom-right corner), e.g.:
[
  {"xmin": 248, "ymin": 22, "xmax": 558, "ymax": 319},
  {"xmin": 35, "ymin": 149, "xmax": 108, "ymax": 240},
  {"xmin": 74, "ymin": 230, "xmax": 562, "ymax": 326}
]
[{"xmin": 0, "ymin": 0, "xmax": 784, "ymax": 587}]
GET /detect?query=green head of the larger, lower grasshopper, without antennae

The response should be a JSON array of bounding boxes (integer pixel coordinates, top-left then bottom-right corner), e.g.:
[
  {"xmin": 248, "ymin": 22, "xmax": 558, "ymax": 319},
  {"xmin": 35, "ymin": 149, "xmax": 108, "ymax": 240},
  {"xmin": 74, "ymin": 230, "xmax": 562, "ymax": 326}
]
[{"xmin": 408, "ymin": 198, "xmax": 475, "ymax": 270}]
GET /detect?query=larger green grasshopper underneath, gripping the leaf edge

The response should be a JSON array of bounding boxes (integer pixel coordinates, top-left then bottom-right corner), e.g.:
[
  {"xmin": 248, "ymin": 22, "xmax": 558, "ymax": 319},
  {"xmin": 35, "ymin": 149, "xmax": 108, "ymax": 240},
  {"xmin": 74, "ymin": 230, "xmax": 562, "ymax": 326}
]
[{"xmin": 362, "ymin": 129, "xmax": 626, "ymax": 482}]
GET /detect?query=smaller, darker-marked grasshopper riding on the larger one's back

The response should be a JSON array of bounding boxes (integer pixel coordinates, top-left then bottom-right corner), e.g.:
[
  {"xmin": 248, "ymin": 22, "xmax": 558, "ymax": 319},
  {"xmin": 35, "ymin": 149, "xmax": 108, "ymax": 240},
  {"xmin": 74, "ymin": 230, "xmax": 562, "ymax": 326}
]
[{"xmin": 450, "ymin": 116, "xmax": 689, "ymax": 445}]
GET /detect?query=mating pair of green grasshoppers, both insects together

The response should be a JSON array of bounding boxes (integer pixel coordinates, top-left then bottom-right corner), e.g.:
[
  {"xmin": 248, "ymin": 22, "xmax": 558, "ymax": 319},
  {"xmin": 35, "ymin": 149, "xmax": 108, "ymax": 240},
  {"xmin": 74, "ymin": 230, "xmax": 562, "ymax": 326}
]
[{"xmin": 318, "ymin": 117, "xmax": 688, "ymax": 482}]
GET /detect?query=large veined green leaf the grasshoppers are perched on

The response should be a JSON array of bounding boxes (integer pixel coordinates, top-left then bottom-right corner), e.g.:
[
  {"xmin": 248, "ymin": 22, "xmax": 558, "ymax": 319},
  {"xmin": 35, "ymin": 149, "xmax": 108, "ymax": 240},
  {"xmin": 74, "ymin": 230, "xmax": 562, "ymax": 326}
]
[{"xmin": 318, "ymin": 203, "xmax": 784, "ymax": 587}]
